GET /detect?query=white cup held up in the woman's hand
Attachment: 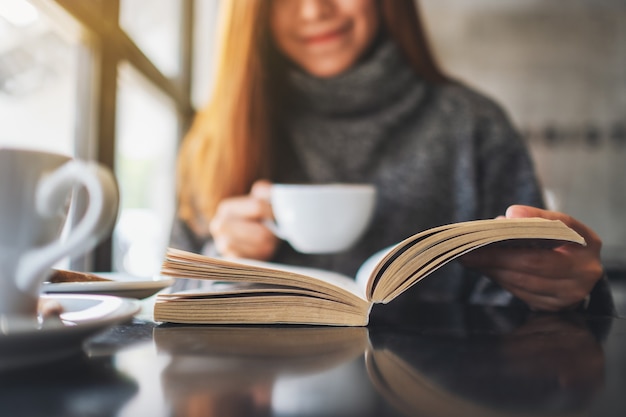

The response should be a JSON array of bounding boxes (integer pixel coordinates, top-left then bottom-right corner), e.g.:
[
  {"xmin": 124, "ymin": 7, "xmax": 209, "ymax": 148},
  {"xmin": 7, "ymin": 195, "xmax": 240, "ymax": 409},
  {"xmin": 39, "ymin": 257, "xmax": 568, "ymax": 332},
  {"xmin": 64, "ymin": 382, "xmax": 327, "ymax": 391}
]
[{"xmin": 269, "ymin": 184, "xmax": 376, "ymax": 253}]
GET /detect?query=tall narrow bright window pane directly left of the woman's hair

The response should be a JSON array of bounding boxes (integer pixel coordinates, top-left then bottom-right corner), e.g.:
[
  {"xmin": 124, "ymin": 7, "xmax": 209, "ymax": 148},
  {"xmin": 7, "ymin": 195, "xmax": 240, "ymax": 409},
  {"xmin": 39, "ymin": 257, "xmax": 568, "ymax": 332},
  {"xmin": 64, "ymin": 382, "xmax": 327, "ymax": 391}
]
[{"xmin": 113, "ymin": 64, "xmax": 178, "ymax": 276}]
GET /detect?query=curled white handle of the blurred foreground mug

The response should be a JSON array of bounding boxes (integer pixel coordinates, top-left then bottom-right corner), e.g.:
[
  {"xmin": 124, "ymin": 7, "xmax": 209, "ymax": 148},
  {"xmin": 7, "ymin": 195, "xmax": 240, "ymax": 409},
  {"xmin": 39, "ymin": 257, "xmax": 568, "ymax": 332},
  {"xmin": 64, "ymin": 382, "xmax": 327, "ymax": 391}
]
[{"xmin": 15, "ymin": 160, "xmax": 119, "ymax": 296}]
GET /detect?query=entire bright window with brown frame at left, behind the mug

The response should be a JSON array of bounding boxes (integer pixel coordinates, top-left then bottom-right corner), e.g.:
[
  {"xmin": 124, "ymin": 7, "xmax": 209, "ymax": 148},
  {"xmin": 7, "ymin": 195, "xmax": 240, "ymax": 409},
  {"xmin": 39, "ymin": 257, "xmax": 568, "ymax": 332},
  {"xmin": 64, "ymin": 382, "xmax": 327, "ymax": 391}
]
[{"xmin": 0, "ymin": 0, "xmax": 197, "ymax": 275}]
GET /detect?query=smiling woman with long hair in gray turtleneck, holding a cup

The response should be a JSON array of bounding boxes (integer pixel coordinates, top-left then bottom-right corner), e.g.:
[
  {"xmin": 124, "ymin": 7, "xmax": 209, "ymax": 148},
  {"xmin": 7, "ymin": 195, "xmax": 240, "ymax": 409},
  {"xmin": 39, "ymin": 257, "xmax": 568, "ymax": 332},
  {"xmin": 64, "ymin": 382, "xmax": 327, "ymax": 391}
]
[{"xmin": 171, "ymin": 0, "xmax": 610, "ymax": 311}]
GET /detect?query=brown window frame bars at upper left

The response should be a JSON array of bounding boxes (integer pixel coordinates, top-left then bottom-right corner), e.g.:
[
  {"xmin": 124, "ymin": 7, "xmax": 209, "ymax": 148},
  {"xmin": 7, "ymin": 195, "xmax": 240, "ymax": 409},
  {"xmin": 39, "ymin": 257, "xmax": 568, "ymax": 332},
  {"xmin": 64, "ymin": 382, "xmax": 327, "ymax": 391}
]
[{"xmin": 31, "ymin": 0, "xmax": 195, "ymax": 271}]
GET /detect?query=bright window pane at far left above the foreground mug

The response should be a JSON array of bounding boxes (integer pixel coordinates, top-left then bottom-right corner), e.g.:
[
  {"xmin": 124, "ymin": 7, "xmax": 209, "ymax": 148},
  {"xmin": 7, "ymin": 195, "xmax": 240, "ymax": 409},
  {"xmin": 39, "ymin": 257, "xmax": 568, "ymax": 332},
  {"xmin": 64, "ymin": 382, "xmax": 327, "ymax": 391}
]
[{"xmin": 0, "ymin": 0, "xmax": 79, "ymax": 155}]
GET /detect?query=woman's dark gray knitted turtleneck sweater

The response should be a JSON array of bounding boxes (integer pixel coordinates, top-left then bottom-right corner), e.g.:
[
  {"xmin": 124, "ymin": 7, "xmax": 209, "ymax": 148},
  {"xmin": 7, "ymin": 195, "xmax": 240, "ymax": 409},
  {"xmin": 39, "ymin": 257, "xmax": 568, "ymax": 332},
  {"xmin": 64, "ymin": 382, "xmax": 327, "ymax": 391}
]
[{"xmin": 171, "ymin": 40, "xmax": 616, "ymax": 312}]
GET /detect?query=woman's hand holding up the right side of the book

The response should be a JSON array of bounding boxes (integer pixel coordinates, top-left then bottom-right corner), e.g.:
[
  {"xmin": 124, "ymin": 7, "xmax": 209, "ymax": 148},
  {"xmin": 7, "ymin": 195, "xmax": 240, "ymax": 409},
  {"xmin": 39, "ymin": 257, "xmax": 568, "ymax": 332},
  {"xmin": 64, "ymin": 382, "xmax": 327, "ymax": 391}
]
[{"xmin": 461, "ymin": 206, "xmax": 603, "ymax": 311}]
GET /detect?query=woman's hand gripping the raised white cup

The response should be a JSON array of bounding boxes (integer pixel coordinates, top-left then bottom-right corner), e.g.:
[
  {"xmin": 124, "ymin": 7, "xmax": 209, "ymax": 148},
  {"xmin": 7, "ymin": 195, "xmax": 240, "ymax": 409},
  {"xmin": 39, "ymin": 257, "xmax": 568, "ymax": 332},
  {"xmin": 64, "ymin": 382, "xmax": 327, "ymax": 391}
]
[{"xmin": 209, "ymin": 180, "xmax": 278, "ymax": 260}]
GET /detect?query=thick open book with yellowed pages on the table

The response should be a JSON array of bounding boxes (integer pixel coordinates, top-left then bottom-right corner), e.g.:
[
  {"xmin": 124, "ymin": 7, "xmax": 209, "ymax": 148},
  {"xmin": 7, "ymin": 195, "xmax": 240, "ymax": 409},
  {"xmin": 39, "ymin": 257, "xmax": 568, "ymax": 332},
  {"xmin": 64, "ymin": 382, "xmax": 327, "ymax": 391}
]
[{"xmin": 154, "ymin": 218, "xmax": 585, "ymax": 326}]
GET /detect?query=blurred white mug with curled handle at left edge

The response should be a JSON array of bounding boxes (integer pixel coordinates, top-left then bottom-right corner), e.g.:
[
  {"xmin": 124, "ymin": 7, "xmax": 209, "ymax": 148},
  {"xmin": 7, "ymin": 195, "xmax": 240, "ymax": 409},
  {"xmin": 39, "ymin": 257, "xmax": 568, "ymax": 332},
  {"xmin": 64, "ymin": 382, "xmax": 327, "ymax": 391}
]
[{"xmin": 0, "ymin": 148, "xmax": 119, "ymax": 318}]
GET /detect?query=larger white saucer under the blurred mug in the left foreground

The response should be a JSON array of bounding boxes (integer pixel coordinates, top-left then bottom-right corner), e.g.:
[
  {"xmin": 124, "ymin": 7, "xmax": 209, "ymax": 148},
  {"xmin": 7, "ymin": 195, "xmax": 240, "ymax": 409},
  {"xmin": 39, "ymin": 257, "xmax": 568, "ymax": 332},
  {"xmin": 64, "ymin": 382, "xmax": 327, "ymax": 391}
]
[{"xmin": 0, "ymin": 294, "xmax": 140, "ymax": 372}]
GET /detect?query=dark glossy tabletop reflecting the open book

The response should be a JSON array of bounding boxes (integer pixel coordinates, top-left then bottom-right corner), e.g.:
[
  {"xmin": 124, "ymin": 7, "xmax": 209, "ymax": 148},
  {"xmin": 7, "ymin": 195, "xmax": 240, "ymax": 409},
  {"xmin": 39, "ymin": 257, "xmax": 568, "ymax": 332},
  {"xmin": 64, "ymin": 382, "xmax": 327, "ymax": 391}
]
[{"xmin": 0, "ymin": 302, "xmax": 626, "ymax": 417}]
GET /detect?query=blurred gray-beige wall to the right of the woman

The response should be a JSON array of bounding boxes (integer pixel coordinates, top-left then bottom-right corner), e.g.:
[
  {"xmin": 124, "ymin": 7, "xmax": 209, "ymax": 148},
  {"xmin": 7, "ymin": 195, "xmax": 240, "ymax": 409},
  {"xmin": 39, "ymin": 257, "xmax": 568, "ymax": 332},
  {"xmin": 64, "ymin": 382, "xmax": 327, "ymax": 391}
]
[{"xmin": 420, "ymin": 0, "xmax": 626, "ymax": 268}]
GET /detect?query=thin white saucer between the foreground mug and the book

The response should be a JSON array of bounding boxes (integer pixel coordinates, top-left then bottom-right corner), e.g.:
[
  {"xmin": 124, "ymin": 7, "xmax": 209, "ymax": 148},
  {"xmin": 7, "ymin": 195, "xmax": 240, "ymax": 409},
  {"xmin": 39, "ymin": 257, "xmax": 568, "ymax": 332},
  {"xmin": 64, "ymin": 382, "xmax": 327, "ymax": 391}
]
[{"xmin": 42, "ymin": 272, "xmax": 174, "ymax": 298}]
